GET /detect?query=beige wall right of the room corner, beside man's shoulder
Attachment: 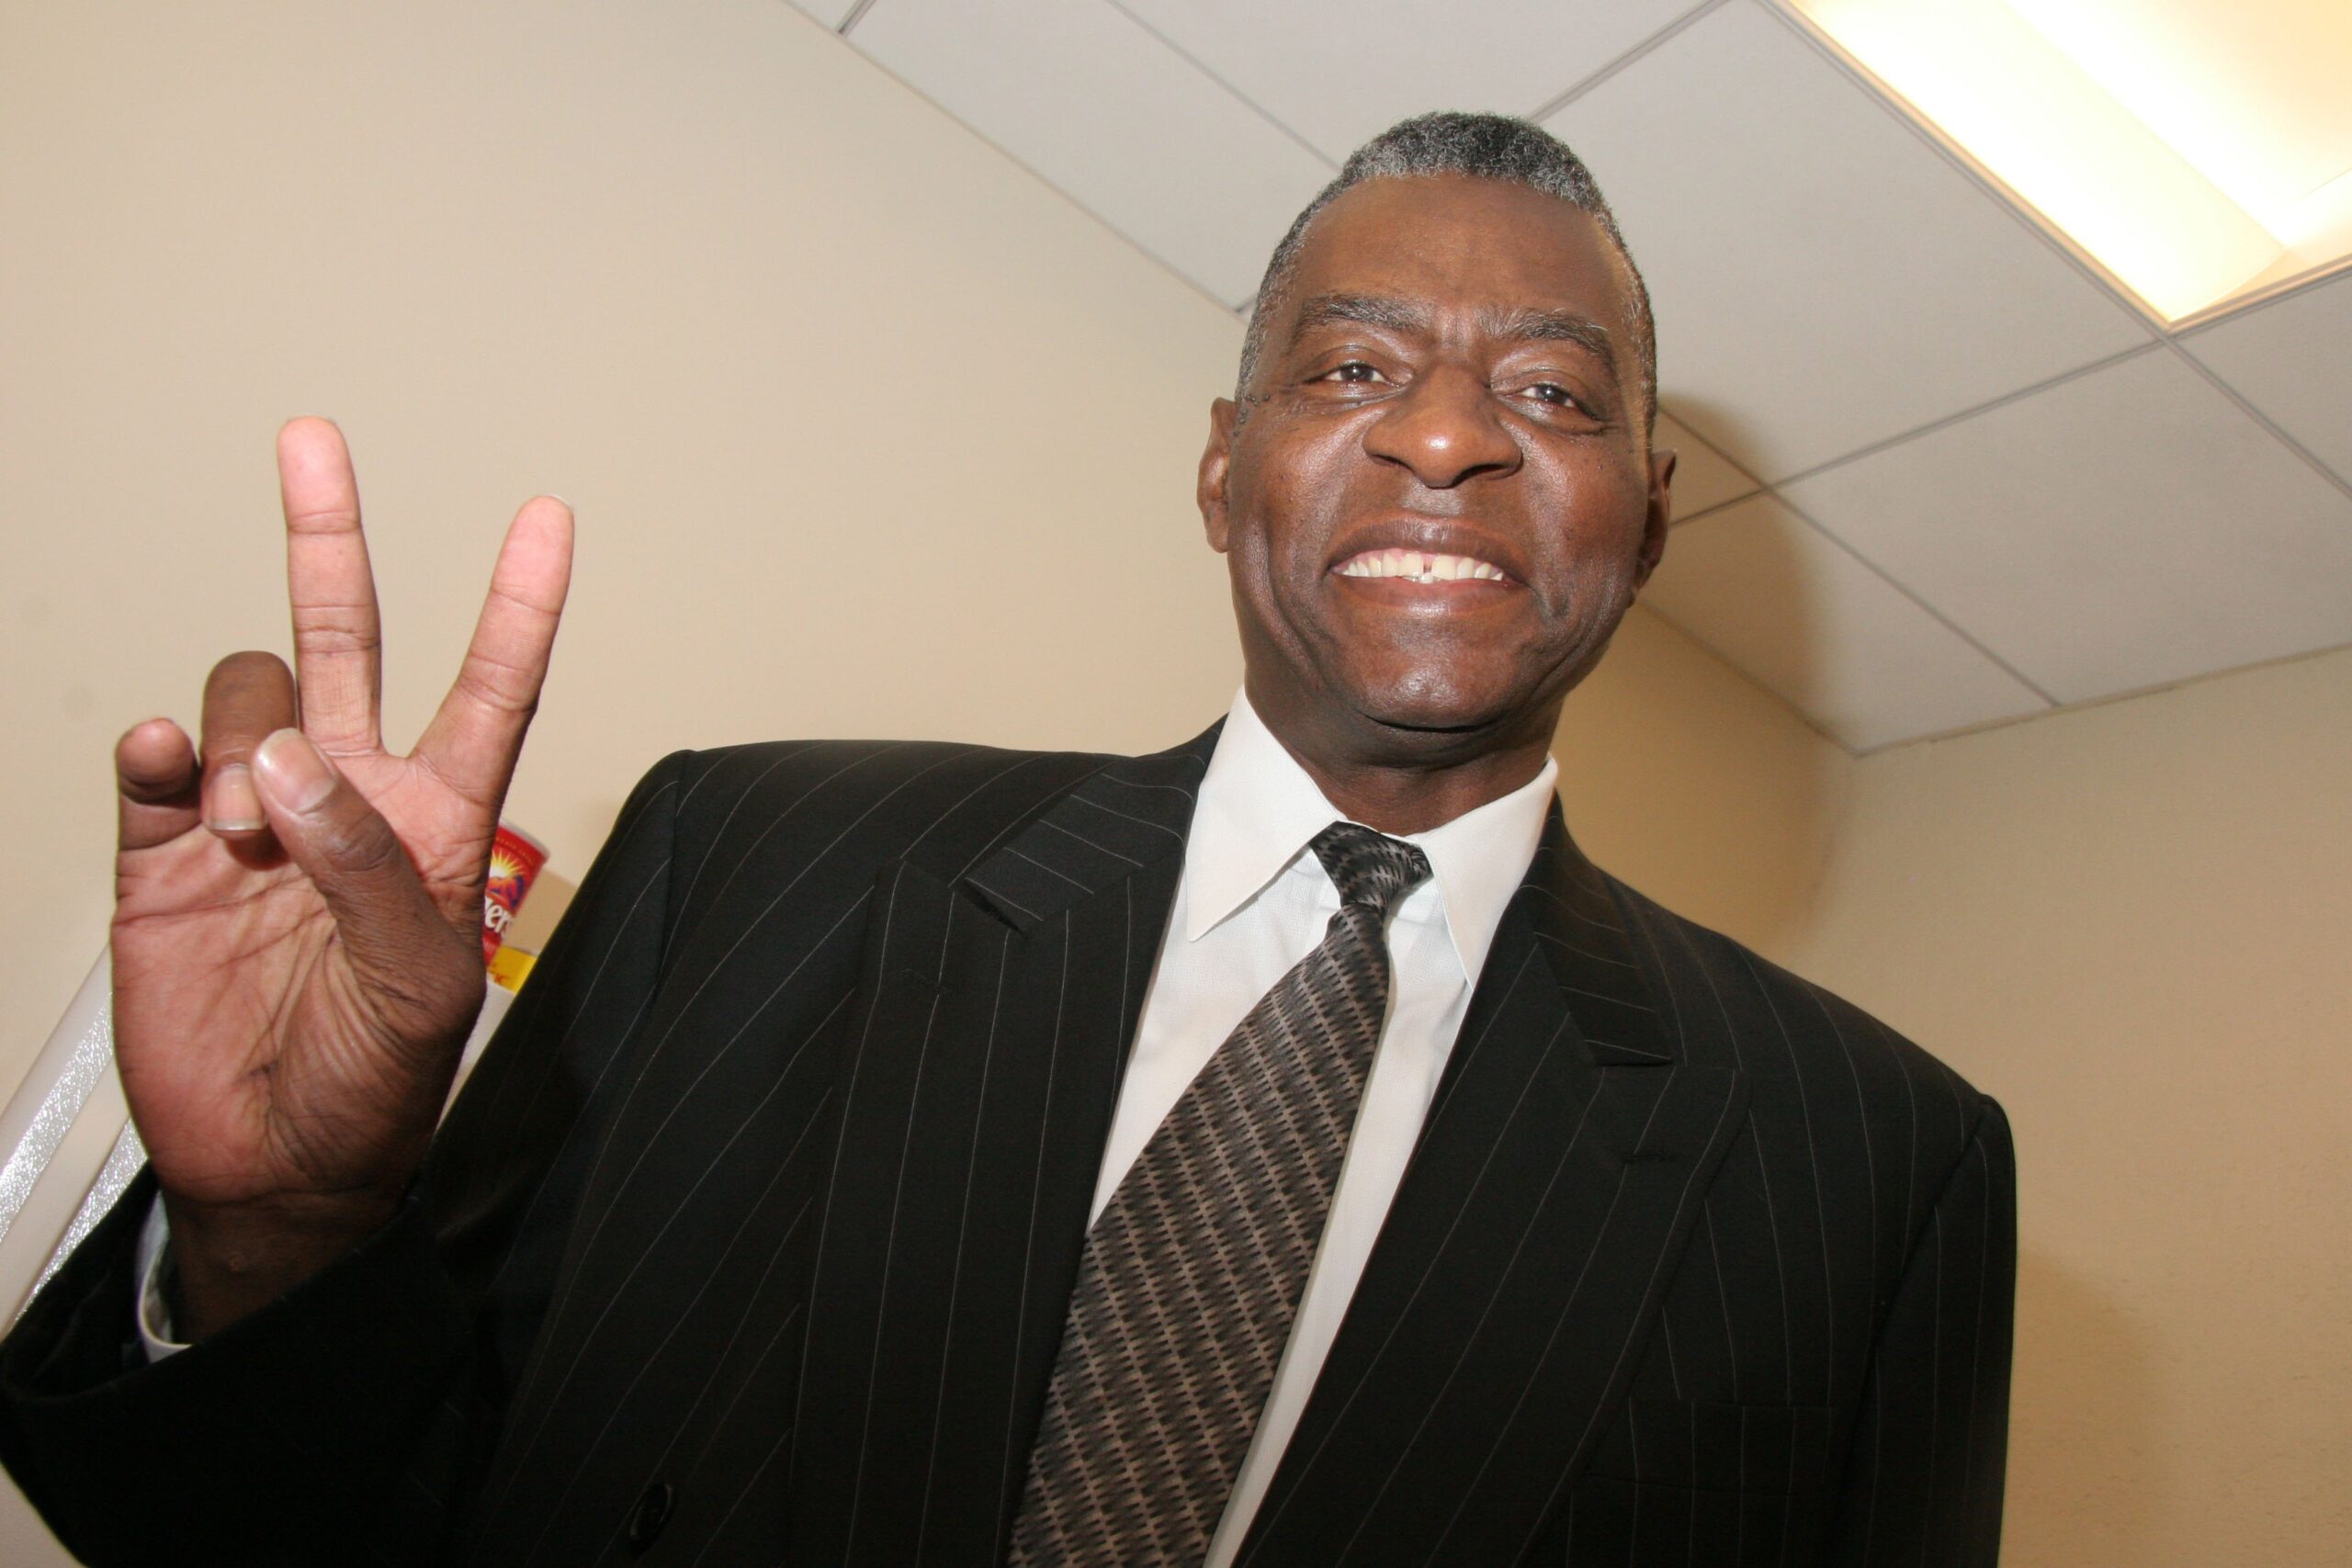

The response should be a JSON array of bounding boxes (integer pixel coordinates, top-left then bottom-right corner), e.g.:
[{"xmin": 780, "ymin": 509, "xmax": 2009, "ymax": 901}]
[{"xmin": 1790, "ymin": 651, "xmax": 2352, "ymax": 1568}]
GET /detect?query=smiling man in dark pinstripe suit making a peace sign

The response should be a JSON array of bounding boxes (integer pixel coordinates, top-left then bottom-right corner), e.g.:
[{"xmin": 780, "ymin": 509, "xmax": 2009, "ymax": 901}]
[{"xmin": 0, "ymin": 115, "xmax": 2013, "ymax": 1565}]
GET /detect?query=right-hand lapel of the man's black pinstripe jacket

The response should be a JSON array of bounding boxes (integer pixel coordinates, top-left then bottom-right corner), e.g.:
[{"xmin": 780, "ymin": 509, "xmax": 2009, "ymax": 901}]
[{"xmin": 1242, "ymin": 804, "xmax": 1746, "ymax": 1568}]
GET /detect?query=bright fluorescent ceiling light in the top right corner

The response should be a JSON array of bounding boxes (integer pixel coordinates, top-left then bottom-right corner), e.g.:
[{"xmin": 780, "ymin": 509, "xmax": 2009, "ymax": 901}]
[{"xmin": 1788, "ymin": 0, "xmax": 2352, "ymax": 322}]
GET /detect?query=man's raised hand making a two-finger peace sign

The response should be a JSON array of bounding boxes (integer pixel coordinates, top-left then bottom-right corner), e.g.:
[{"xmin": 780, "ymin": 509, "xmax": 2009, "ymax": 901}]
[{"xmin": 113, "ymin": 419, "xmax": 571, "ymax": 1340}]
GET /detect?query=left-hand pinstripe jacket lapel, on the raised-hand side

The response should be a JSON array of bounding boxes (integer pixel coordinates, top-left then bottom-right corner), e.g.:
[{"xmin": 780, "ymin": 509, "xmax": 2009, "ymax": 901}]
[{"xmin": 790, "ymin": 728, "xmax": 1216, "ymax": 1565}]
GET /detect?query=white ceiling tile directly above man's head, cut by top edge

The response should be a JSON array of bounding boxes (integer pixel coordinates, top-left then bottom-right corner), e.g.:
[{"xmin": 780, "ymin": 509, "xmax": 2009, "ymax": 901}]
[{"xmin": 1113, "ymin": 0, "xmax": 1696, "ymax": 164}]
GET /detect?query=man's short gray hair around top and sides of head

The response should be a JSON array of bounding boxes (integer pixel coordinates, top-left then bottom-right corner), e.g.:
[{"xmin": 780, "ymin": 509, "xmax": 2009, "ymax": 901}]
[{"xmin": 1232, "ymin": 110, "xmax": 1658, "ymax": 430}]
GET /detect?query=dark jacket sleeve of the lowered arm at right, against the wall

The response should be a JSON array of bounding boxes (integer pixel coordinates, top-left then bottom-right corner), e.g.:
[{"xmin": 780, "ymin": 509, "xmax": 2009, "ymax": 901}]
[{"xmin": 1826, "ymin": 1100, "xmax": 2018, "ymax": 1568}]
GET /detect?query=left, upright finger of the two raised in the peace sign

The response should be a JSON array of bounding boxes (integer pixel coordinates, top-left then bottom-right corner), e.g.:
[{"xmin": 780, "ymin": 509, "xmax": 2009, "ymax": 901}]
[{"xmin": 277, "ymin": 419, "xmax": 383, "ymax": 755}]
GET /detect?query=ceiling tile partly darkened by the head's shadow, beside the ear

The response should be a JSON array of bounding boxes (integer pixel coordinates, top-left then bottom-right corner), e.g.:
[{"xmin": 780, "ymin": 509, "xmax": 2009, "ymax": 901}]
[{"xmin": 1642, "ymin": 496, "xmax": 2046, "ymax": 752}]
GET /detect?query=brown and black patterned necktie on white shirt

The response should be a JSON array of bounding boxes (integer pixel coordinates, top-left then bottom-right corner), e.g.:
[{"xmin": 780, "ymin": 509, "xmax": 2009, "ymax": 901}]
[{"xmin": 1009, "ymin": 823, "xmax": 1430, "ymax": 1568}]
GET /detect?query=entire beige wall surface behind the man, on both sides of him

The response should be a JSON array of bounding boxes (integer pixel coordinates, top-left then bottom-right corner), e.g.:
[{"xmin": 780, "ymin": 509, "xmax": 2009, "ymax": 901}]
[{"xmin": 0, "ymin": 0, "xmax": 2352, "ymax": 1568}]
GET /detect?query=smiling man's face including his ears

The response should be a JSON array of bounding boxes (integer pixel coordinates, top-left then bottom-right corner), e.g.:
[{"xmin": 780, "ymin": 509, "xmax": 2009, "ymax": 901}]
[{"xmin": 1200, "ymin": 176, "xmax": 1672, "ymax": 760}]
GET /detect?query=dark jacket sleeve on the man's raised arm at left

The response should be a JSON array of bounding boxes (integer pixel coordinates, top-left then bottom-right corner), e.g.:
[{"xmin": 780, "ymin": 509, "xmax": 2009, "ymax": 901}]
[{"xmin": 0, "ymin": 755, "xmax": 687, "ymax": 1568}]
